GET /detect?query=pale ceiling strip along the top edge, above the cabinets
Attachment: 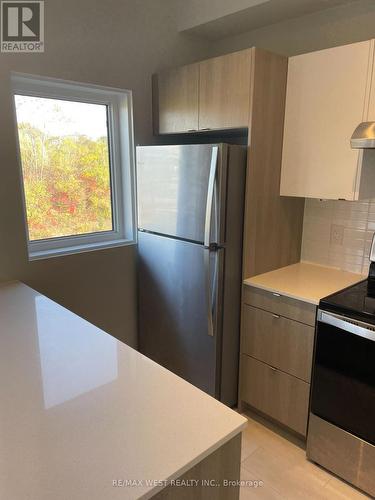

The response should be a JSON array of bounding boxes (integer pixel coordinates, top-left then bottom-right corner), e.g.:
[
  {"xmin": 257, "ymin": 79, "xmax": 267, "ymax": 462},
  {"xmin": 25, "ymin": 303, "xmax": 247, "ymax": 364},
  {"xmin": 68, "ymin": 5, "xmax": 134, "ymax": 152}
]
[{"xmin": 179, "ymin": 0, "xmax": 354, "ymax": 40}]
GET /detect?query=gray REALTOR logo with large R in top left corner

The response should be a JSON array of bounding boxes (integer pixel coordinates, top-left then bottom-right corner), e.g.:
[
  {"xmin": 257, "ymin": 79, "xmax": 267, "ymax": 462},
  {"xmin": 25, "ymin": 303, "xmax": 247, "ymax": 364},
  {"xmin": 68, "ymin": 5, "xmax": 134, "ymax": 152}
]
[{"xmin": 1, "ymin": 0, "xmax": 44, "ymax": 52}]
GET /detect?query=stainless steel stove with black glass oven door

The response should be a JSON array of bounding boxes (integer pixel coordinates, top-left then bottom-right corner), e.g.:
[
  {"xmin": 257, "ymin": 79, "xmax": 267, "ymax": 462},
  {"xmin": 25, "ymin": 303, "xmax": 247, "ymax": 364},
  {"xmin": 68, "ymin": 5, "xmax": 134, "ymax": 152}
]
[{"xmin": 307, "ymin": 236, "xmax": 375, "ymax": 497}]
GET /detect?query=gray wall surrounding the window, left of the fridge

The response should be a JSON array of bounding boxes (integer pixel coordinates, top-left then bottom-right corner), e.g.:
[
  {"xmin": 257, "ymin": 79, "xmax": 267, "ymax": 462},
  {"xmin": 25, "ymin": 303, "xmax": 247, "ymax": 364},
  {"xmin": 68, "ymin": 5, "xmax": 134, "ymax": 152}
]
[{"xmin": 0, "ymin": 0, "xmax": 212, "ymax": 346}]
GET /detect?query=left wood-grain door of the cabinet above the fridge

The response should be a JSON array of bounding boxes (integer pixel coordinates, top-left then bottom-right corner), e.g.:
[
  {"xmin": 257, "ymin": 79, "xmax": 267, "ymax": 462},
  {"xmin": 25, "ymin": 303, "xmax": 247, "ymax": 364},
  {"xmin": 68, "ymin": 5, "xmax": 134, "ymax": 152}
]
[{"xmin": 154, "ymin": 64, "xmax": 199, "ymax": 134}]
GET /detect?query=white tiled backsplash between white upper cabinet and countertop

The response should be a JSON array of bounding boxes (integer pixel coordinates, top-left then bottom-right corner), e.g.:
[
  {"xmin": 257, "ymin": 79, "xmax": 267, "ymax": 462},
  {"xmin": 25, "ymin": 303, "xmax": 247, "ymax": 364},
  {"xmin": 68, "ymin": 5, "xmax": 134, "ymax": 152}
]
[{"xmin": 301, "ymin": 199, "xmax": 375, "ymax": 274}]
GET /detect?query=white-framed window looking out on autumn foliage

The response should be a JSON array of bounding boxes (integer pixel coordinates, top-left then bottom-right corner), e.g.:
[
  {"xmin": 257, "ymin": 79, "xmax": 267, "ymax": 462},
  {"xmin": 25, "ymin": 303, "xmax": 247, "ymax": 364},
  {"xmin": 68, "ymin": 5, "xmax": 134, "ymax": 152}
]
[{"xmin": 12, "ymin": 74, "xmax": 135, "ymax": 259}]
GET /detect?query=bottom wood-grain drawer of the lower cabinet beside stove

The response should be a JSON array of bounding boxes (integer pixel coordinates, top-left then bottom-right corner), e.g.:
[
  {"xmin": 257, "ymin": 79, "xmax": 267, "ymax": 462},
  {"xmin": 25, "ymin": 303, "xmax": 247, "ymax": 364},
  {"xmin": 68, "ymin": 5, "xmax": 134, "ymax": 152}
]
[{"xmin": 241, "ymin": 354, "xmax": 310, "ymax": 436}]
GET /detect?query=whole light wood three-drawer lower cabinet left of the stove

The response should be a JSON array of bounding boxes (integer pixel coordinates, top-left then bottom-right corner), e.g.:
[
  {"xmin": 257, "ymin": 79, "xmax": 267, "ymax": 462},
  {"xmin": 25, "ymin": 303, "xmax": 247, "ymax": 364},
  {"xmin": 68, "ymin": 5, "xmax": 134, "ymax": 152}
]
[{"xmin": 239, "ymin": 285, "xmax": 316, "ymax": 436}]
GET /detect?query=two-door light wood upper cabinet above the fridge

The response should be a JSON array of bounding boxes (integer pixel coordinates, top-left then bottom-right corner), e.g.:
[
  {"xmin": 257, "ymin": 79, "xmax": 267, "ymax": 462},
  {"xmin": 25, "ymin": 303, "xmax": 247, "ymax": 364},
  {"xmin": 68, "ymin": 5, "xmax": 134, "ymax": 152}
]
[{"xmin": 153, "ymin": 49, "xmax": 252, "ymax": 134}]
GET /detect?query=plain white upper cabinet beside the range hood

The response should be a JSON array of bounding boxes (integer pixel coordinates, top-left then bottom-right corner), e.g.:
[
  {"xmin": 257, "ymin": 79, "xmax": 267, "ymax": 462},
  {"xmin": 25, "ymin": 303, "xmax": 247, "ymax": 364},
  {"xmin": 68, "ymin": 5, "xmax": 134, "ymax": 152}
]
[{"xmin": 280, "ymin": 41, "xmax": 372, "ymax": 200}]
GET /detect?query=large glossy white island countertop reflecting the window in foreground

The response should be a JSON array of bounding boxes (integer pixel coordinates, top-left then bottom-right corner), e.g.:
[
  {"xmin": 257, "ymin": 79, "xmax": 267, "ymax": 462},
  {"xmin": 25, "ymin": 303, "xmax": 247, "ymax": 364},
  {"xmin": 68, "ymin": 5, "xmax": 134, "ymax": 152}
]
[{"xmin": 0, "ymin": 282, "xmax": 246, "ymax": 500}]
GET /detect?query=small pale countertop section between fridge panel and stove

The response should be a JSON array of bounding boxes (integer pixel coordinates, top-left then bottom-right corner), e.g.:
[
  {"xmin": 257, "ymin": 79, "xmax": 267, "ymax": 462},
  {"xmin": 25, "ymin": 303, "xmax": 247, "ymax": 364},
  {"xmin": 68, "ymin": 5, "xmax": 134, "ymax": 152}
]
[{"xmin": 244, "ymin": 262, "xmax": 365, "ymax": 305}]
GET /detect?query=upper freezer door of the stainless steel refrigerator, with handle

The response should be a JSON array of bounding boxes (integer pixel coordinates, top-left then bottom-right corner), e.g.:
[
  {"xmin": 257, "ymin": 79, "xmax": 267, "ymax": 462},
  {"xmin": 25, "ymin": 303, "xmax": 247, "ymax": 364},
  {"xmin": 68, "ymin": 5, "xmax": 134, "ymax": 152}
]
[{"xmin": 137, "ymin": 144, "xmax": 227, "ymax": 244}]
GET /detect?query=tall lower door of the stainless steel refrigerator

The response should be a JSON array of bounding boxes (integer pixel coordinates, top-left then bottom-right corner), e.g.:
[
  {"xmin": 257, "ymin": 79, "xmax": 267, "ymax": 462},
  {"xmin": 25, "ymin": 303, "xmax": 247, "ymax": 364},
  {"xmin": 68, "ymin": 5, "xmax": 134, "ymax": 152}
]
[{"xmin": 138, "ymin": 232, "xmax": 224, "ymax": 397}]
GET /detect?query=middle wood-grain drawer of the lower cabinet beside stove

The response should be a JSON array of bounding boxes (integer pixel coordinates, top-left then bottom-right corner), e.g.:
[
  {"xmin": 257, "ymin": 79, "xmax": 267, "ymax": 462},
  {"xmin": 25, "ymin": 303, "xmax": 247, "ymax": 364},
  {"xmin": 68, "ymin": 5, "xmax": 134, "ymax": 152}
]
[{"xmin": 242, "ymin": 305, "xmax": 314, "ymax": 383}]
